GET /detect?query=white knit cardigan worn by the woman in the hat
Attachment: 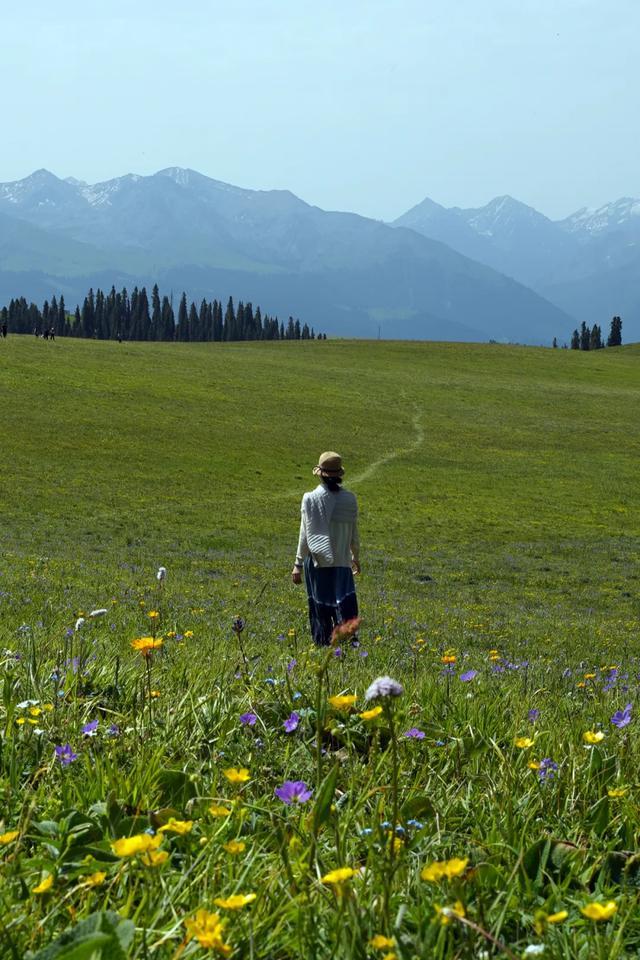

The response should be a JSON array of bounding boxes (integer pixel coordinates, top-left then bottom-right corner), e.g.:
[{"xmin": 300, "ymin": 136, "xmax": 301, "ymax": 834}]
[{"xmin": 296, "ymin": 483, "xmax": 360, "ymax": 567}]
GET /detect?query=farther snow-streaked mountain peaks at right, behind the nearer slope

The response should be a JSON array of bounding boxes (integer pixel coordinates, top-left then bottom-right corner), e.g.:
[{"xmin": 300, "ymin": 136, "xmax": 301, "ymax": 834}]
[{"xmin": 394, "ymin": 197, "xmax": 640, "ymax": 339}]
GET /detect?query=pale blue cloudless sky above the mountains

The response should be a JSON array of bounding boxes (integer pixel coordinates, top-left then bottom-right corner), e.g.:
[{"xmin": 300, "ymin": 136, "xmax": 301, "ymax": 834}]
[{"xmin": 0, "ymin": 0, "xmax": 640, "ymax": 219}]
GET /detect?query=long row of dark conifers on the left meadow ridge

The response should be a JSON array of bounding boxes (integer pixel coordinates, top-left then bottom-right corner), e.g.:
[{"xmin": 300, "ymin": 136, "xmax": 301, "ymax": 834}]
[{"xmin": 0, "ymin": 284, "xmax": 327, "ymax": 342}]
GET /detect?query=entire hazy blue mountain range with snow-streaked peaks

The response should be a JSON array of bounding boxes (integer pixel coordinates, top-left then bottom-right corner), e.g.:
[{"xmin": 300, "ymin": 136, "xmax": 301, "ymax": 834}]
[{"xmin": 0, "ymin": 167, "xmax": 640, "ymax": 343}]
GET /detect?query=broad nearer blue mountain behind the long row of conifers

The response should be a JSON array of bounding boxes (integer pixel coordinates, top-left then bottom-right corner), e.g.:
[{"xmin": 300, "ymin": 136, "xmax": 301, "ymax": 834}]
[{"xmin": 0, "ymin": 167, "xmax": 574, "ymax": 343}]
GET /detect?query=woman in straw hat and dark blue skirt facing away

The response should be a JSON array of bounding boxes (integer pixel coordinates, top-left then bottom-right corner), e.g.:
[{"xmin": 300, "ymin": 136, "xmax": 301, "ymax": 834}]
[{"xmin": 291, "ymin": 450, "xmax": 360, "ymax": 646}]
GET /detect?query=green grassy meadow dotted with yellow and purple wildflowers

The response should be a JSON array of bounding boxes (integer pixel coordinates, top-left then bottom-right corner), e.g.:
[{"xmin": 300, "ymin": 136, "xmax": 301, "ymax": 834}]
[{"xmin": 0, "ymin": 337, "xmax": 640, "ymax": 960}]
